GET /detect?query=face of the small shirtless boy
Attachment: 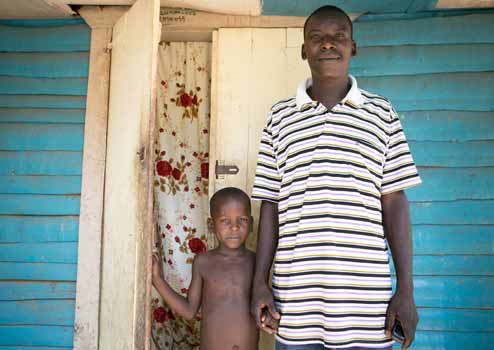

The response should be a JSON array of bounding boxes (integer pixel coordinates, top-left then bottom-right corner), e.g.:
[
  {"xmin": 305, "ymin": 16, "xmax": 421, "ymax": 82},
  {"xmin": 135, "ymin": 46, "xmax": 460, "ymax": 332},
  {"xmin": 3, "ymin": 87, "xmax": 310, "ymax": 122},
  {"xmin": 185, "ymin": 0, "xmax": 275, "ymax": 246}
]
[{"xmin": 209, "ymin": 198, "xmax": 252, "ymax": 249}]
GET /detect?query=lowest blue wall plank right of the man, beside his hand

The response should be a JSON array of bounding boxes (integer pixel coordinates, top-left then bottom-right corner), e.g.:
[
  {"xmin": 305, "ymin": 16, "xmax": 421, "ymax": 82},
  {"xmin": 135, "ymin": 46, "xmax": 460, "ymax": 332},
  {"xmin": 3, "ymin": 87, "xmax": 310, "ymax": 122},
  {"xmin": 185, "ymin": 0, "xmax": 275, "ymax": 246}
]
[{"xmin": 408, "ymin": 331, "xmax": 492, "ymax": 350}]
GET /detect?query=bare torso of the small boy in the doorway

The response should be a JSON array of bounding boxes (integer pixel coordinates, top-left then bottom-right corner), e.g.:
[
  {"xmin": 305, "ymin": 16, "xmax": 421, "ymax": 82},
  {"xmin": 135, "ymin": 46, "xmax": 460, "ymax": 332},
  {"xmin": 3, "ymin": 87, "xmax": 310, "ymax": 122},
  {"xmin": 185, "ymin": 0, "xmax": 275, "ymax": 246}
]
[{"xmin": 199, "ymin": 249, "xmax": 259, "ymax": 350}]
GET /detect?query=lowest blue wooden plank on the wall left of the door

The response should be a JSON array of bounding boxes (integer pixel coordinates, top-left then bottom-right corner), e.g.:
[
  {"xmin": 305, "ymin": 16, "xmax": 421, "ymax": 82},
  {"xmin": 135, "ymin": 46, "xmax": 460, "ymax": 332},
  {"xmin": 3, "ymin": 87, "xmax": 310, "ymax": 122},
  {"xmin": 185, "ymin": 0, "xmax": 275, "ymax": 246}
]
[{"xmin": 0, "ymin": 325, "xmax": 74, "ymax": 346}]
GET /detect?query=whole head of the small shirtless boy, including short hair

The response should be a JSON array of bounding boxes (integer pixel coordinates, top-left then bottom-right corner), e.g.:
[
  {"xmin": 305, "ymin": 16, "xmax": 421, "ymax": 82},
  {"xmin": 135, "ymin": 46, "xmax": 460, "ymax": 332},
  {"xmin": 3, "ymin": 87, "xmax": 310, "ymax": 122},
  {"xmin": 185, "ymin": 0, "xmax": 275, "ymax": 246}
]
[{"xmin": 208, "ymin": 187, "xmax": 252, "ymax": 249}]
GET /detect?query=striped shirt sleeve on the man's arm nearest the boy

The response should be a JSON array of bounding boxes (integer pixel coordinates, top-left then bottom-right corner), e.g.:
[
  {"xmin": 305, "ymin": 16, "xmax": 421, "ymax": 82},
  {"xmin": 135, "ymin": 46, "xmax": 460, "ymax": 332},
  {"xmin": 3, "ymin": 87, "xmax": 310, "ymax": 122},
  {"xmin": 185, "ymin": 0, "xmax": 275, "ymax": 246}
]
[{"xmin": 252, "ymin": 114, "xmax": 281, "ymax": 203}]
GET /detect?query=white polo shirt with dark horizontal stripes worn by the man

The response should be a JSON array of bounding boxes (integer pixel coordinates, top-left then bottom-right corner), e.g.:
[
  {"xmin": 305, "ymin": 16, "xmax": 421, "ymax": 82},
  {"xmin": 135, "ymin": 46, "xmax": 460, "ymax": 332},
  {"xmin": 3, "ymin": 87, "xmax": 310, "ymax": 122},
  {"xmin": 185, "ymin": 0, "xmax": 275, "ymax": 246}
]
[{"xmin": 252, "ymin": 76, "xmax": 421, "ymax": 348}]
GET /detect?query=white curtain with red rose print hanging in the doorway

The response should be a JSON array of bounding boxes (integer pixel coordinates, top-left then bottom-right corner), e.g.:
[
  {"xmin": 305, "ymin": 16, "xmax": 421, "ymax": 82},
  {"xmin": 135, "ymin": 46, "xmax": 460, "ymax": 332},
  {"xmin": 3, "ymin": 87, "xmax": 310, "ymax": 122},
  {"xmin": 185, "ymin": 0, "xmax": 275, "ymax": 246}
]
[{"xmin": 152, "ymin": 42, "xmax": 211, "ymax": 350}]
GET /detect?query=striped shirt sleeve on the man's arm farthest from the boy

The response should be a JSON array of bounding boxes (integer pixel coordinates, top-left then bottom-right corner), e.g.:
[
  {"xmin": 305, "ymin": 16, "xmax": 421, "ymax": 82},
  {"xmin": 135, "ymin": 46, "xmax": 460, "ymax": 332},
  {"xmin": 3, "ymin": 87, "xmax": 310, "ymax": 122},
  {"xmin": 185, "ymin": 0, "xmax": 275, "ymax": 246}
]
[{"xmin": 381, "ymin": 109, "xmax": 422, "ymax": 194}]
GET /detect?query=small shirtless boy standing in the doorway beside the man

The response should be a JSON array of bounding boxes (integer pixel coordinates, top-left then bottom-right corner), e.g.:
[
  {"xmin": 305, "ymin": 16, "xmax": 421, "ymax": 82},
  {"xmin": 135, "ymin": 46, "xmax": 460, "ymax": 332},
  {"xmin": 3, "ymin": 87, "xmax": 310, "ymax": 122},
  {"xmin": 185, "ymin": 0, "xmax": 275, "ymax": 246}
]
[{"xmin": 153, "ymin": 187, "xmax": 259, "ymax": 350}]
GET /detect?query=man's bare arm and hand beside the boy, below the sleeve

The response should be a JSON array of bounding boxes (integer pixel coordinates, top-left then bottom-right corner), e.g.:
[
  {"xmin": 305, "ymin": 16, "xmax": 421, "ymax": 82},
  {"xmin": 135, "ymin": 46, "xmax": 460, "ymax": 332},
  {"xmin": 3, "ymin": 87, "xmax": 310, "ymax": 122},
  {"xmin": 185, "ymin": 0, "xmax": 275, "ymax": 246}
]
[{"xmin": 251, "ymin": 201, "xmax": 280, "ymax": 334}]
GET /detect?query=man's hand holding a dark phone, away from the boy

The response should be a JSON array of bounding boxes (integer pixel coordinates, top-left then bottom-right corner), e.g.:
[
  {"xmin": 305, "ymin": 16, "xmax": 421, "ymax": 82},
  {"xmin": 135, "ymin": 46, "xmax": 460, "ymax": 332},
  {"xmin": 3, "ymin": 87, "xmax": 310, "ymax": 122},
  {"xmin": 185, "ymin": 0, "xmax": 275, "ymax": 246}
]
[{"xmin": 385, "ymin": 292, "xmax": 419, "ymax": 349}]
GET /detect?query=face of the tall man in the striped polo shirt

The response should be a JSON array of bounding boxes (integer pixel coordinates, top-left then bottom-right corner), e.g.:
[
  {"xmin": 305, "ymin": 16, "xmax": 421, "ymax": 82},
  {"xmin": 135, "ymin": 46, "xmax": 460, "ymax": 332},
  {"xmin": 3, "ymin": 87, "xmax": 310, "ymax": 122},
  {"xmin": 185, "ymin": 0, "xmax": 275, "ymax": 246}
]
[{"xmin": 302, "ymin": 12, "xmax": 357, "ymax": 79}]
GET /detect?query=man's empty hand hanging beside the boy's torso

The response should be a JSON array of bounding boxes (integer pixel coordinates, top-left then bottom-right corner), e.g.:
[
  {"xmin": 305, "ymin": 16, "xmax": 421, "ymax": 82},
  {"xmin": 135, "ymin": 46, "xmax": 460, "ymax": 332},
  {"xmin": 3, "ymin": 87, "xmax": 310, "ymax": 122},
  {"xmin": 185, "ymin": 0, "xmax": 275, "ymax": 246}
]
[{"xmin": 250, "ymin": 285, "xmax": 280, "ymax": 334}]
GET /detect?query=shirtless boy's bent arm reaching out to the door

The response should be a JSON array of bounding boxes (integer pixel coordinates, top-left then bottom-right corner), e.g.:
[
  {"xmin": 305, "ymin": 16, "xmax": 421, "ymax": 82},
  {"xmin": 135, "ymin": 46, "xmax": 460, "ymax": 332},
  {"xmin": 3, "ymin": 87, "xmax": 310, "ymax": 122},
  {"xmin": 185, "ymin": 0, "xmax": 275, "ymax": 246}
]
[{"xmin": 153, "ymin": 256, "xmax": 202, "ymax": 320}]
